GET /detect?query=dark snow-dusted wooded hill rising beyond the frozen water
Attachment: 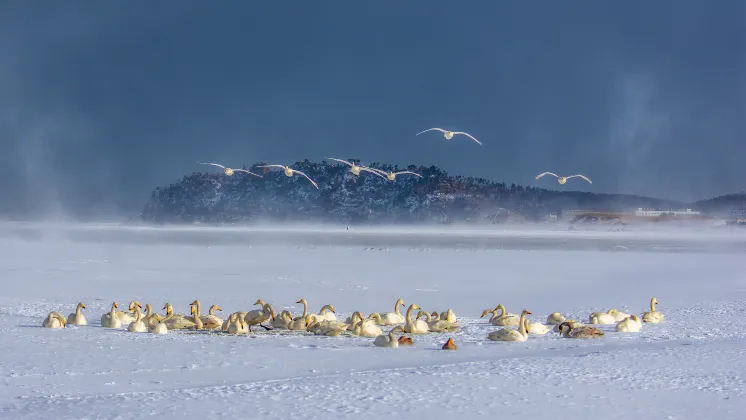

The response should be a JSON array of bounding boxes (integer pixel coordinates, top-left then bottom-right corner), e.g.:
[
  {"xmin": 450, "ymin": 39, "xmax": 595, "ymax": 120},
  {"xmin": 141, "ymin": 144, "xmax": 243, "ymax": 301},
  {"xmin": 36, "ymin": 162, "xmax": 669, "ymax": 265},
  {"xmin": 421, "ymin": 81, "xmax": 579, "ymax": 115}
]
[{"xmin": 141, "ymin": 160, "xmax": 681, "ymax": 223}]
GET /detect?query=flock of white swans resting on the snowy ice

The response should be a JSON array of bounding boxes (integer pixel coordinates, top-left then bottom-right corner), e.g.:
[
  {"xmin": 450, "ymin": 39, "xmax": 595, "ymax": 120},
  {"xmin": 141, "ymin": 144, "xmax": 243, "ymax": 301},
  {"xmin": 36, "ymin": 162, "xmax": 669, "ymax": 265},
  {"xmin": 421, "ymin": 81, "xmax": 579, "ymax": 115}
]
[{"xmin": 42, "ymin": 298, "xmax": 664, "ymax": 350}]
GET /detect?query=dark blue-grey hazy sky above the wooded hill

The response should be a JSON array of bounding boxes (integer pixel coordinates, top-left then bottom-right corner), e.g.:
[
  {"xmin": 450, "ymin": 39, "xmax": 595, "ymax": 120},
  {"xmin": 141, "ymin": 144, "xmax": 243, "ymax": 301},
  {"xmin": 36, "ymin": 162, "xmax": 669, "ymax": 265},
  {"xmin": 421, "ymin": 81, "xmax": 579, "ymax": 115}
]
[{"xmin": 0, "ymin": 0, "xmax": 746, "ymax": 214}]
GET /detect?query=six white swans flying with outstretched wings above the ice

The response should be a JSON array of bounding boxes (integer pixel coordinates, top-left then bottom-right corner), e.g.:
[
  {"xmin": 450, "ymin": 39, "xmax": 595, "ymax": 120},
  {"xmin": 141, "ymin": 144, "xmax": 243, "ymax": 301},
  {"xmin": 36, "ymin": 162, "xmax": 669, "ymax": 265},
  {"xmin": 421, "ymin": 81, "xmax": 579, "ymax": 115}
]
[{"xmin": 197, "ymin": 127, "xmax": 593, "ymax": 189}]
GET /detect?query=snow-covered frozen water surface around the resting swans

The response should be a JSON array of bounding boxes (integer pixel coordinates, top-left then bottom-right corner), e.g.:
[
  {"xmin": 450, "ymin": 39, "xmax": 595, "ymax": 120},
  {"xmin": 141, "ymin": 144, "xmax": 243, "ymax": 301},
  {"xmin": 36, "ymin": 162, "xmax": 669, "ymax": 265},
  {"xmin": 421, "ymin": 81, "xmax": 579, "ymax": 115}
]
[{"xmin": 0, "ymin": 221, "xmax": 746, "ymax": 419}]
